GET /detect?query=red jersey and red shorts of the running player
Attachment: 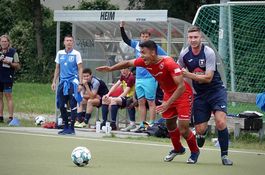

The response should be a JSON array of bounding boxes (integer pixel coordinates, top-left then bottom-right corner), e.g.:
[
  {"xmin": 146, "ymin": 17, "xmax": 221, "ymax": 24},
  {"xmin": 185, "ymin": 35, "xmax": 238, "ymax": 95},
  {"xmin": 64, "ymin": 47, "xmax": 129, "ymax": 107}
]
[{"xmin": 134, "ymin": 57, "xmax": 193, "ymax": 120}]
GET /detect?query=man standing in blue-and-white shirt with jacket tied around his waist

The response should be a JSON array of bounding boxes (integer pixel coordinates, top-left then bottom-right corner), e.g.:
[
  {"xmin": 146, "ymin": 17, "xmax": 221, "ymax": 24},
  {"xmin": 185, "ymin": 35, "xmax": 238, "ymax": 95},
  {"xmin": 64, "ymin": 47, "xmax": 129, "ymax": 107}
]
[{"xmin": 51, "ymin": 35, "xmax": 83, "ymax": 135}]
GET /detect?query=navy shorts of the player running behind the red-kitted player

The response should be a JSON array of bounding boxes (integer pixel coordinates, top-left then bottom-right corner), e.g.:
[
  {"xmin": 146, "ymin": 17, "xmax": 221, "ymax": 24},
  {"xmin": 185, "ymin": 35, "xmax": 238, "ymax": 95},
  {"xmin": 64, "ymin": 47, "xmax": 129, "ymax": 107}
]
[{"xmin": 193, "ymin": 88, "xmax": 227, "ymax": 125}]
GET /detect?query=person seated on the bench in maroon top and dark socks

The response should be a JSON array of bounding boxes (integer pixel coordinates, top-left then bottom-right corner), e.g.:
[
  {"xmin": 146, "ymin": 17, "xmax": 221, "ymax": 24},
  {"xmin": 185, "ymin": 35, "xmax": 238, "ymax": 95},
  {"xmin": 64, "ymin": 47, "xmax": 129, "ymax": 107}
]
[{"xmin": 101, "ymin": 68, "xmax": 135, "ymax": 130}]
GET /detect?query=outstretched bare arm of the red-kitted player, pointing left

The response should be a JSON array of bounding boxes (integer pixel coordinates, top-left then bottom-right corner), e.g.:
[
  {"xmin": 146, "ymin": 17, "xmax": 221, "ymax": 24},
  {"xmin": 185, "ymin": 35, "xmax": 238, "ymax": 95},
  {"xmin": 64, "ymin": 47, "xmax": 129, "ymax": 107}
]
[{"xmin": 96, "ymin": 59, "xmax": 135, "ymax": 72}]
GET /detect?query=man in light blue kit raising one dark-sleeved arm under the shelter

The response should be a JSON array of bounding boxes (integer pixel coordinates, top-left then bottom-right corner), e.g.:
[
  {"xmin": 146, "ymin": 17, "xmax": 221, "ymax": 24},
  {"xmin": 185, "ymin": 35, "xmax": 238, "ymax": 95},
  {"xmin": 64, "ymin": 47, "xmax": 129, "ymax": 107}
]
[{"xmin": 120, "ymin": 21, "xmax": 167, "ymax": 132}]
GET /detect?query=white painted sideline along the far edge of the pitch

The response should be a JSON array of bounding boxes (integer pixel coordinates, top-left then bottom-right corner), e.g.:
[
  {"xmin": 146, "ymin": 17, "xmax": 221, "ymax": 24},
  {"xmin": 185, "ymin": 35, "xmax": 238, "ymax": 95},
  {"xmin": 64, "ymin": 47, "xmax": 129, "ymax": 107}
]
[{"xmin": 0, "ymin": 129, "xmax": 265, "ymax": 156}]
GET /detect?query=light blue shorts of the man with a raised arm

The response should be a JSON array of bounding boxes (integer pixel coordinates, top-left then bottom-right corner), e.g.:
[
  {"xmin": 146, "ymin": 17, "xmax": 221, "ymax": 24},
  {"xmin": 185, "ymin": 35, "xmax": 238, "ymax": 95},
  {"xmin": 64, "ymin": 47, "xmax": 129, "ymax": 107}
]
[{"xmin": 135, "ymin": 78, "xmax": 157, "ymax": 100}]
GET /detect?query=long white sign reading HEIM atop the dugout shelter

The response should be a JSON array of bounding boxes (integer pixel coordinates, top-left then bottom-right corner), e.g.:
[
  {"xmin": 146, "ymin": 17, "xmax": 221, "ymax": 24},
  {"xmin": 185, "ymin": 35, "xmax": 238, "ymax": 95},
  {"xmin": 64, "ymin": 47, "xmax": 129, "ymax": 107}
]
[{"xmin": 54, "ymin": 10, "xmax": 167, "ymax": 22}]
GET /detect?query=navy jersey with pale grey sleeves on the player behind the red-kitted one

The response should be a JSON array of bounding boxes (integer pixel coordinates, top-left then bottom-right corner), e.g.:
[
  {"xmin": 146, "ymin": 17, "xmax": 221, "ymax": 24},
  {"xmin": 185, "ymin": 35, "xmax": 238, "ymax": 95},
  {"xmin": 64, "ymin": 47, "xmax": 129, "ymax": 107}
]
[{"xmin": 178, "ymin": 44, "xmax": 224, "ymax": 94}]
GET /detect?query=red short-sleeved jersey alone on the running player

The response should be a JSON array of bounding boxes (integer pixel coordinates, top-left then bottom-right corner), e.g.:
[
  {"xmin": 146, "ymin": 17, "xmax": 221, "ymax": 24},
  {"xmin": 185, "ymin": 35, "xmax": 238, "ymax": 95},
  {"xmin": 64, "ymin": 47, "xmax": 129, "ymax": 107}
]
[{"xmin": 134, "ymin": 57, "xmax": 192, "ymax": 94}]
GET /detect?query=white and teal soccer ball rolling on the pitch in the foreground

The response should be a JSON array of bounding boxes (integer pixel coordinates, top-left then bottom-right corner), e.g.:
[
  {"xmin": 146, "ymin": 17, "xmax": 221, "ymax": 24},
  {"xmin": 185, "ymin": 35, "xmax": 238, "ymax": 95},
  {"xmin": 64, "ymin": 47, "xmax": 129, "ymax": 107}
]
[{"xmin": 71, "ymin": 146, "xmax": 91, "ymax": 167}]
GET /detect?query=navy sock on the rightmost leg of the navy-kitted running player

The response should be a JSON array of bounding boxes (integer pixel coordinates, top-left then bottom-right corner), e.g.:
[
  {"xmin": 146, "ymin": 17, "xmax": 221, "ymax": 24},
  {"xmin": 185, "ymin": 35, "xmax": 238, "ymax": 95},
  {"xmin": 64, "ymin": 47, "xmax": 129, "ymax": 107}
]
[{"xmin": 218, "ymin": 128, "xmax": 229, "ymax": 156}]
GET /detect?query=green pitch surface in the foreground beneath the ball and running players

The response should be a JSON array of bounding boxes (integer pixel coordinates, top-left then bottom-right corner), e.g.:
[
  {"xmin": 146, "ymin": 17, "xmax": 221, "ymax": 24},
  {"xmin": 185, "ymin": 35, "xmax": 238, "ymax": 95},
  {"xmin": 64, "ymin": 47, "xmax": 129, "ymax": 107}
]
[{"xmin": 0, "ymin": 130, "xmax": 265, "ymax": 175}]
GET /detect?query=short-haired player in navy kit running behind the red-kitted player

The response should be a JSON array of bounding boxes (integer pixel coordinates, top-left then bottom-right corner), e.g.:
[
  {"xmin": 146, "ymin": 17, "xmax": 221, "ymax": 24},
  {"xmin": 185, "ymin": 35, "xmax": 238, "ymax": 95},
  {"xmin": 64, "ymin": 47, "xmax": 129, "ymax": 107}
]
[{"xmin": 178, "ymin": 26, "xmax": 233, "ymax": 165}]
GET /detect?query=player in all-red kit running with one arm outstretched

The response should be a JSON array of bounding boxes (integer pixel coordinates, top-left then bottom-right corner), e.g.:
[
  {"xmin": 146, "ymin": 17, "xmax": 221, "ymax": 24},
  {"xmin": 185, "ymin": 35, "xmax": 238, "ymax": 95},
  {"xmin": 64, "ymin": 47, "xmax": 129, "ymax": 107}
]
[{"xmin": 96, "ymin": 40, "xmax": 200, "ymax": 164}]
